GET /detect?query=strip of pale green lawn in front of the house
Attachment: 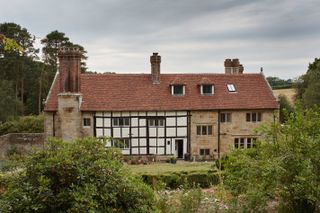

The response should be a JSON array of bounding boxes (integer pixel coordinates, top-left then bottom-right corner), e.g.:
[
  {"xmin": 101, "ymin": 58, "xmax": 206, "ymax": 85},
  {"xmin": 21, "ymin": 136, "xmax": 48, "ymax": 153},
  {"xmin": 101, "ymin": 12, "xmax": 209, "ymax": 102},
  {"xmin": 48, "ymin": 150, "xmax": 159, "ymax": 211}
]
[{"xmin": 126, "ymin": 161, "xmax": 213, "ymax": 175}]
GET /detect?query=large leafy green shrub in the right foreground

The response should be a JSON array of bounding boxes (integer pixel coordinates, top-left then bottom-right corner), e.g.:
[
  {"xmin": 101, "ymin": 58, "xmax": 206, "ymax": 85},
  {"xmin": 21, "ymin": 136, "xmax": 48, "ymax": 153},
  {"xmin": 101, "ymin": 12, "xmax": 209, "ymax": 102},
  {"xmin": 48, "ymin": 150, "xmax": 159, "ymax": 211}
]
[{"xmin": 224, "ymin": 107, "xmax": 320, "ymax": 212}]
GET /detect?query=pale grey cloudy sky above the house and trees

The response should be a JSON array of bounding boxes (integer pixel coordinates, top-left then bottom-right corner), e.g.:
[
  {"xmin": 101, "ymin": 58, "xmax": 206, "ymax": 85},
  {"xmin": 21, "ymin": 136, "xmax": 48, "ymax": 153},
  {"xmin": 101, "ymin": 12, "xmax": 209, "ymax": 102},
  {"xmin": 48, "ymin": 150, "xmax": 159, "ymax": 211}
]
[{"xmin": 0, "ymin": 0, "xmax": 320, "ymax": 79}]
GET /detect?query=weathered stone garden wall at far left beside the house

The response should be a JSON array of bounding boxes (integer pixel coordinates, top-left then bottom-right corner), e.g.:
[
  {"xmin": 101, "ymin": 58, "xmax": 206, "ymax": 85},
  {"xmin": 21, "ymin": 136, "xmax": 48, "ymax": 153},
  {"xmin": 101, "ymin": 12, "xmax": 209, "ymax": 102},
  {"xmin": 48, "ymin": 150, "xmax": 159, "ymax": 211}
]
[{"xmin": 0, "ymin": 133, "xmax": 44, "ymax": 159}]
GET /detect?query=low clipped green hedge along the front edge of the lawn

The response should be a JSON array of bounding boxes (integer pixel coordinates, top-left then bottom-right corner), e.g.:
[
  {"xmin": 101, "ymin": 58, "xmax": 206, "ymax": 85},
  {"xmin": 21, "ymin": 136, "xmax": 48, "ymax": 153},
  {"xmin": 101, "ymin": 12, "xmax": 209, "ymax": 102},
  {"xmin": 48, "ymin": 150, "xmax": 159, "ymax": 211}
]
[{"xmin": 141, "ymin": 170, "xmax": 219, "ymax": 189}]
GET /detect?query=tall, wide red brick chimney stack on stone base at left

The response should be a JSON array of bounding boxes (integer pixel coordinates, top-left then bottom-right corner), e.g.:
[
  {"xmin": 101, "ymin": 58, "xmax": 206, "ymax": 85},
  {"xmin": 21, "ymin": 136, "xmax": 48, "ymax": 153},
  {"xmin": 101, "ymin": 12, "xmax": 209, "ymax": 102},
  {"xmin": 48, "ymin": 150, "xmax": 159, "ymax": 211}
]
[{"xmin": 58, "ymin": 47, "xmax": 81, "ymax": 93}]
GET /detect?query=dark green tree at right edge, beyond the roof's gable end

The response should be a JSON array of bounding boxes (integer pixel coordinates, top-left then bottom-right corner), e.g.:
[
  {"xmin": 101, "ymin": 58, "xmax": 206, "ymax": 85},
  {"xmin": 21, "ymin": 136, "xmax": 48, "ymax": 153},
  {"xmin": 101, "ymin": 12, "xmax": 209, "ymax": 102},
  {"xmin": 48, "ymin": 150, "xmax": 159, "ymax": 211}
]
[{"xmin": 296, "ymin": 58, "xmax": 320, "ymax": 107}]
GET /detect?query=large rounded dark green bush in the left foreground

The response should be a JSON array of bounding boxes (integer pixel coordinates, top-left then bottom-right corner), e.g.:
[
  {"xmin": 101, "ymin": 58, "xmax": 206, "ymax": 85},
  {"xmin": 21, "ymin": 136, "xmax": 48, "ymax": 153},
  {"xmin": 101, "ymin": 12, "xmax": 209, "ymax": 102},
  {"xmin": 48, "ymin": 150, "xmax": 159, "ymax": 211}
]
[{"xmin": 0, "ymin": 138, "xmax": 155, "ymax": 212}]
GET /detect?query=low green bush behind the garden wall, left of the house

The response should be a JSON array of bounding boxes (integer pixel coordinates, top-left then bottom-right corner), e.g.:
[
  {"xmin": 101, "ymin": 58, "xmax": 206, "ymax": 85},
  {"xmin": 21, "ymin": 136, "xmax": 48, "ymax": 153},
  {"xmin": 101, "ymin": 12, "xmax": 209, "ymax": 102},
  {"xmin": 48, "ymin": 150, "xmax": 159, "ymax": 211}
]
[{"xmin": 0, "ymin": 115, "xmax": 44, "ymax": 135}]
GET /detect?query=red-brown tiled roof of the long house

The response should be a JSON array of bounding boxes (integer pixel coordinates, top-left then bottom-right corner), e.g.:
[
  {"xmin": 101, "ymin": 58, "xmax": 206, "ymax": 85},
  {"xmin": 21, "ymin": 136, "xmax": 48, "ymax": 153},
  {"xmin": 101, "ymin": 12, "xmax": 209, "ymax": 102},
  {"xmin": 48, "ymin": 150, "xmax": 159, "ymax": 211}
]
[{"xmin": 45, "ymin": 74, "xmax": 278, "ymax": 111}]
